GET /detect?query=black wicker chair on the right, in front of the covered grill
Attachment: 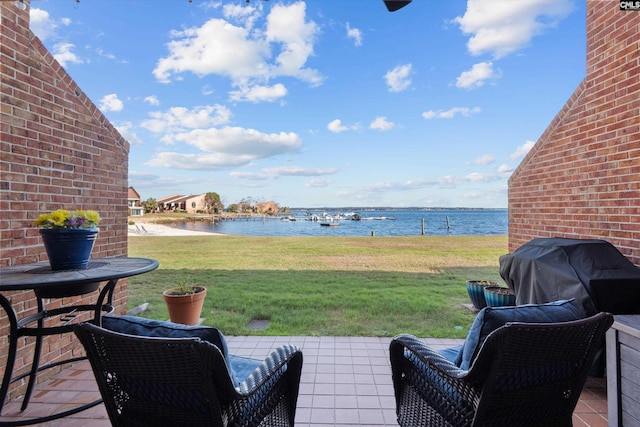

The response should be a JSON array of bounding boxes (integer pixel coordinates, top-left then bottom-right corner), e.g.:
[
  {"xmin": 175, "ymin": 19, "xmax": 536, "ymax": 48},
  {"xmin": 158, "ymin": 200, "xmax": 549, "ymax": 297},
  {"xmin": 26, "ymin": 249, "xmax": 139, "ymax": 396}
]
[{"xmin": 390, "ymin": 313, "xmax": 613, "ymax": 427}]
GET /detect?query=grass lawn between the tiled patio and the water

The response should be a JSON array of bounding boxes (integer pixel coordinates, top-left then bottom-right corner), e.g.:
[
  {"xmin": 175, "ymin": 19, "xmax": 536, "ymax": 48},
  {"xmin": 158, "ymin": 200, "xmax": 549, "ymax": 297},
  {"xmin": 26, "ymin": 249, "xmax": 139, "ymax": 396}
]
[{"xmin": 128, "ymin": 236, "xmax": 507, "ymax": 338}]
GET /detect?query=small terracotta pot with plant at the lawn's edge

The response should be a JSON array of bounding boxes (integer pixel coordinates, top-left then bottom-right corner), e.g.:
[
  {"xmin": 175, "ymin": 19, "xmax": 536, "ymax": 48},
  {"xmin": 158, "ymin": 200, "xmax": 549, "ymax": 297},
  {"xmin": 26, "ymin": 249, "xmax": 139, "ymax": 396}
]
[{"xmin": 162, "ymin": 279, "xmax": 207, "ymax": 325}]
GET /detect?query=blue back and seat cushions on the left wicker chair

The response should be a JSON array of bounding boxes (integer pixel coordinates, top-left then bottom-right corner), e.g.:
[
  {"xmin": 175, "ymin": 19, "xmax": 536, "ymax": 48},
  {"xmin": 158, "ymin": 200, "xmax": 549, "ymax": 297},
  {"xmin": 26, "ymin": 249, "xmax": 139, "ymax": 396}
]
[{"xmin": 102, "ymin": 316, "xmax": 254, "ymax": 387}]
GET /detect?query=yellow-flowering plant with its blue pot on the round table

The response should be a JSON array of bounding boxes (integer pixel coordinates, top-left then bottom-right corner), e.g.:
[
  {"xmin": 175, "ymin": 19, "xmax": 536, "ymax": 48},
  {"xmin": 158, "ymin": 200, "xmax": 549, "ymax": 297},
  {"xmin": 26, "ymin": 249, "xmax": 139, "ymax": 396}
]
[{"xmin": 33, "ymin": 209, "xmax": 100, "ymax": 270}]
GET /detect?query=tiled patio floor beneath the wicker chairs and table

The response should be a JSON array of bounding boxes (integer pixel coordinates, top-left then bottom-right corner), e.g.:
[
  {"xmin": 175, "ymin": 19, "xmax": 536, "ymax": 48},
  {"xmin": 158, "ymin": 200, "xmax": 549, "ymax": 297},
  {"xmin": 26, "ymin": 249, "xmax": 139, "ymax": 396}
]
[{"xmin": 0, "ymin": 336, "xmax": 607, "ymax": 427}]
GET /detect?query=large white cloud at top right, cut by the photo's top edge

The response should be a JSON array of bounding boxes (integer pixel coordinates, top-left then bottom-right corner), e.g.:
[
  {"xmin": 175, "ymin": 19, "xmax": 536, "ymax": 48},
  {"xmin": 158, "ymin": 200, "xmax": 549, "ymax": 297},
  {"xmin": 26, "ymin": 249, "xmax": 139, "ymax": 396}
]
[{"xmin": 453, "ymin": 0, "xmax": 573, "ymax": 59}]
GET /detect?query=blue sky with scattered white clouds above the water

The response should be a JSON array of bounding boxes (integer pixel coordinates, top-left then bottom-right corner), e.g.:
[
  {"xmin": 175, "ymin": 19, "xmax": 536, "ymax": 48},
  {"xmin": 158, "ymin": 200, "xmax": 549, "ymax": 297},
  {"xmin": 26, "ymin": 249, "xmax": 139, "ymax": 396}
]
[{"xmin": 30, "ymin": 0, "xmax": 586, "ymax": 208}]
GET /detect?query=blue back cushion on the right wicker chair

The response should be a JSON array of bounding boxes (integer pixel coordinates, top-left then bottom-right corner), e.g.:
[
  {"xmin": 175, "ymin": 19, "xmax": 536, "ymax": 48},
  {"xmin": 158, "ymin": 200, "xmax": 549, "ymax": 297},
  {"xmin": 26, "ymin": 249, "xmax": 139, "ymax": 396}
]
[{"xmin": 454, "ymin": 298, "xmax": 585, "ymax": 370}]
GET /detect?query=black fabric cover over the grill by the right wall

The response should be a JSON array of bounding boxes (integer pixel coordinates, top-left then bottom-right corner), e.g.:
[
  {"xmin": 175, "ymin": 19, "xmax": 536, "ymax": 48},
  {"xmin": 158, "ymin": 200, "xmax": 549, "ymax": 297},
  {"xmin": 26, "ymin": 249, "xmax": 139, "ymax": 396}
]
[{"xmin": 500, "ymin": 238, "xmax": 640, "ymax": 316}]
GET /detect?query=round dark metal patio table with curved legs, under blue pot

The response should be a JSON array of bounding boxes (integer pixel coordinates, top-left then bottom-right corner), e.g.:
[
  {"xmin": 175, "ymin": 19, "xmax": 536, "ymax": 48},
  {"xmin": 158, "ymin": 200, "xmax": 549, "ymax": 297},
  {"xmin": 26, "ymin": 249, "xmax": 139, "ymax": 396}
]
[{"xmin": 0, "ymin": 258, "xmax": 158, "ymax": 425}]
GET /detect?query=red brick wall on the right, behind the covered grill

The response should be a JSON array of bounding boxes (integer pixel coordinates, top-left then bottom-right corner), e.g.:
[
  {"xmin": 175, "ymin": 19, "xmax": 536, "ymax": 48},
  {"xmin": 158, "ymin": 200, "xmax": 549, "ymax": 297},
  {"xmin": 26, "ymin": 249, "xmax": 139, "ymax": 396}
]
[{"xmin": 509, "ymin": 0, "xmax": 640, "ymax": 265}]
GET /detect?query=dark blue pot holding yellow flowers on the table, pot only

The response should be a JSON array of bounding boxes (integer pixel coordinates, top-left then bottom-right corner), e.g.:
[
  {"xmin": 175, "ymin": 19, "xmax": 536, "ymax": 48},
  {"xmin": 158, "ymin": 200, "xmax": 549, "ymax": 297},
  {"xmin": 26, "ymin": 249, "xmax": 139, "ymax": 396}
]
[{"xmin": 40, "ymin": 227, "xmax": 100, "ymax": 270}]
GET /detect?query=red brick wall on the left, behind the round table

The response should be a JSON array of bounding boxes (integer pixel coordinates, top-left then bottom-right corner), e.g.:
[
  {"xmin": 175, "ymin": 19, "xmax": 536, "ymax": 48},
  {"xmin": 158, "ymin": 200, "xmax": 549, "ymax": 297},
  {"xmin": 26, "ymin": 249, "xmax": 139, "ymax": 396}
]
[{"xmin": 0, "ymin": 1, "xmax": 129, "ymax": 404}]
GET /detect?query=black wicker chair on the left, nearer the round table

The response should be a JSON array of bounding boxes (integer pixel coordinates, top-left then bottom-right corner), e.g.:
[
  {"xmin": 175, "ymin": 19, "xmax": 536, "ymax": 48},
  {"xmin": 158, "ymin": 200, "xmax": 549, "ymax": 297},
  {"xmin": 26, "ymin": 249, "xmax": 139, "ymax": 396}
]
[{"xmin": 75, "ymin": 323, "xmax": 302, "ymax": 427}]
